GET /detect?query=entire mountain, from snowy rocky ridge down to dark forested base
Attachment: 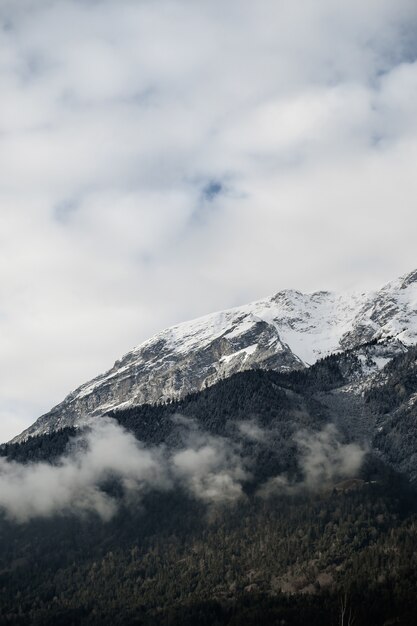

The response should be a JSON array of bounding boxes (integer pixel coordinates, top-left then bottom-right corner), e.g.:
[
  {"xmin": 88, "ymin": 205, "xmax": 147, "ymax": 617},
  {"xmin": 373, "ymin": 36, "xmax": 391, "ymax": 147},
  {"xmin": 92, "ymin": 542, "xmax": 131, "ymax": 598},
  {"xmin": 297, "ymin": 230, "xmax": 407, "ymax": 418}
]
[{"xmin": 0, "ymin": 273, "xmax": 417, "ymax": 626}]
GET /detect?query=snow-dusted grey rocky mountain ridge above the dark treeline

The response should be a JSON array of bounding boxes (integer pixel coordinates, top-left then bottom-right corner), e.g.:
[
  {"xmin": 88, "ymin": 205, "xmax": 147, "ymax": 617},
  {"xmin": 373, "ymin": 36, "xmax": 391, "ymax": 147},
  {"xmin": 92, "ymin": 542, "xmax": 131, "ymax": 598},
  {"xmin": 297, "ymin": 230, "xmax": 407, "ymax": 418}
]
[{"xmin": 14, "ymin": 270, "xmax": 417, "ymax": 442}]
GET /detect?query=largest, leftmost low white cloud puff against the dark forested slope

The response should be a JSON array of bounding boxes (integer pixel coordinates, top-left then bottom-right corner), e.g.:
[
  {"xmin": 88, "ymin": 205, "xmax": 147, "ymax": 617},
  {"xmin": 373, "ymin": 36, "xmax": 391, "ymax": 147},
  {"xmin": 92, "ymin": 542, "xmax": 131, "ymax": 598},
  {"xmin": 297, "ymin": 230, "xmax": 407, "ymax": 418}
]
[{"xmin": 0, "ymin": 420, "xmax": 169, "ymax": 522}]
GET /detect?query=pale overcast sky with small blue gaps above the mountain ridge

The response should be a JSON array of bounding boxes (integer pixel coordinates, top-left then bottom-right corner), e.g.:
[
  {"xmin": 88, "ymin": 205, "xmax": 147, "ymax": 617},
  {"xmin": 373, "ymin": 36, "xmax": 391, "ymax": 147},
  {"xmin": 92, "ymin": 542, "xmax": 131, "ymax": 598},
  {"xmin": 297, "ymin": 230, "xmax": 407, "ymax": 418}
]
[{"xmin": 0, "ymin": 0, "xmax": 417, "ymax": 440}]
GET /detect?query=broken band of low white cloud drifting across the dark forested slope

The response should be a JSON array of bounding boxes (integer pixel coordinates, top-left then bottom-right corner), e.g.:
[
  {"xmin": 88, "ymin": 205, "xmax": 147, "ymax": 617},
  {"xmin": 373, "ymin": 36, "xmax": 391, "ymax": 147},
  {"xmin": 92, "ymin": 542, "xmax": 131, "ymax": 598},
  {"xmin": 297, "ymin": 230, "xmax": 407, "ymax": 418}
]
[{"xmin": 0, "ymin": 416, "xmax": 365, "ymax": 522}]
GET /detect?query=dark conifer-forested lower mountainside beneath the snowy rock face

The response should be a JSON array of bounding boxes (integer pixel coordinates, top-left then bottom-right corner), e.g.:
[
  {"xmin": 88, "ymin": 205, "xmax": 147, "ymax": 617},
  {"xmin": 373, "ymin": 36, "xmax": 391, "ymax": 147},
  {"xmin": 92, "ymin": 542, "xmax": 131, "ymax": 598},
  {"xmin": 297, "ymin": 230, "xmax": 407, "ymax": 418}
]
[{"xmin": 0, "ymin": 352, "xmax": 417, "ymax": 626}]
